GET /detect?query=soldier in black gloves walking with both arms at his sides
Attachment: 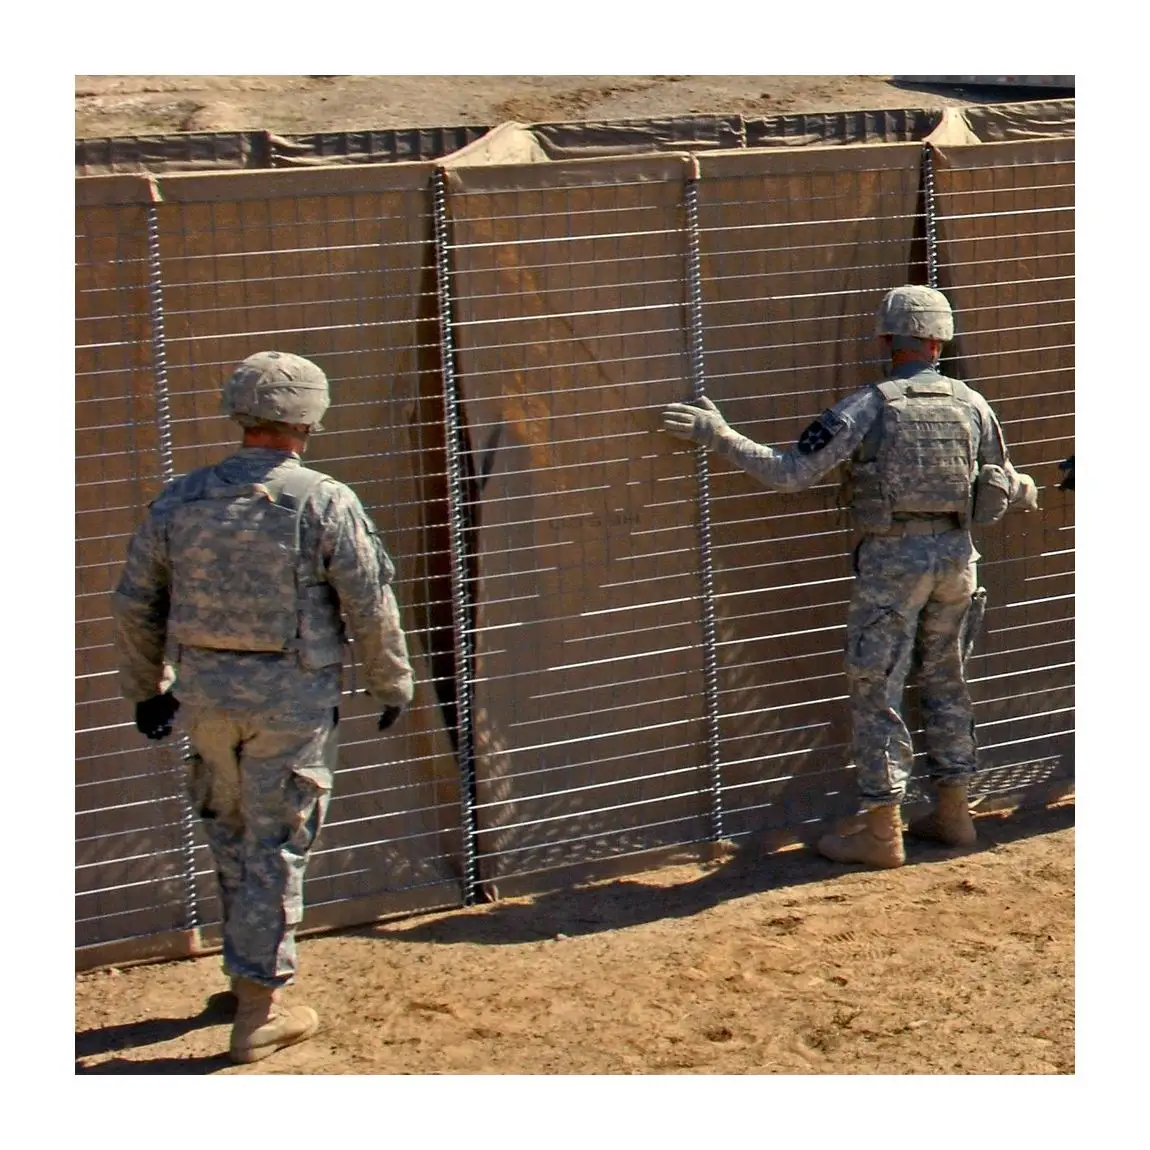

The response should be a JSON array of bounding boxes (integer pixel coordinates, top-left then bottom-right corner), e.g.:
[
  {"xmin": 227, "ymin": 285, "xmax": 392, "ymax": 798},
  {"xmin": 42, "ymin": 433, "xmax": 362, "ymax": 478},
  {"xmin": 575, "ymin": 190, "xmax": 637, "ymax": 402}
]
[{"xmin": 113, "ymin": 352, "xmax": 413, "ymax": 1063}]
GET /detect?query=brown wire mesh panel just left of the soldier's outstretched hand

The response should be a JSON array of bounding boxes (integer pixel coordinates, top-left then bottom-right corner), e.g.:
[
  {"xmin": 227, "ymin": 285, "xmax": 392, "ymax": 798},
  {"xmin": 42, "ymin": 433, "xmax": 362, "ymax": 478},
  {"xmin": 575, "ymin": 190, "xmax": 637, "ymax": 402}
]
[{"xmin": 449, "ymin": 158, "xmax": 707, "ymax": 880}]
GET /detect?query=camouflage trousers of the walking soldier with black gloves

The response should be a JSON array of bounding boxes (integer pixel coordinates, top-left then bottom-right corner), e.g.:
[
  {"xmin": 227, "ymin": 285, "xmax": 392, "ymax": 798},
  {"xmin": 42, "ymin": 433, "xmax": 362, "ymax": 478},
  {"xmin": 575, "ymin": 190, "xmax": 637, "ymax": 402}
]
[{"xmin": 182, "ymin": 707, "xmax": 338, "ymax": 987}]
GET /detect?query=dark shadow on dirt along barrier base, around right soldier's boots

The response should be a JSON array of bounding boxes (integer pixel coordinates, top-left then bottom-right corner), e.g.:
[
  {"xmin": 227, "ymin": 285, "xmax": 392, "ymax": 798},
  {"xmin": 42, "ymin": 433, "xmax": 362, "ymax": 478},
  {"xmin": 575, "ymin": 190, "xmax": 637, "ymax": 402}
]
[{"xmin": 368, "ymin": 803, "xmax": 1074, "ymax": 945}]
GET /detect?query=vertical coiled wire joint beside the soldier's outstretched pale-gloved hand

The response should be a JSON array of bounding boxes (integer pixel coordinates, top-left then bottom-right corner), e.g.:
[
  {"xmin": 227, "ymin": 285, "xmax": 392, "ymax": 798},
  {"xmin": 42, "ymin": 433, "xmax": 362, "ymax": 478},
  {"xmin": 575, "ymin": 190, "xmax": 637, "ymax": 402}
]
[{"xmin": 684, "ymin": 177, "xmax": 723, "ymax": 842}]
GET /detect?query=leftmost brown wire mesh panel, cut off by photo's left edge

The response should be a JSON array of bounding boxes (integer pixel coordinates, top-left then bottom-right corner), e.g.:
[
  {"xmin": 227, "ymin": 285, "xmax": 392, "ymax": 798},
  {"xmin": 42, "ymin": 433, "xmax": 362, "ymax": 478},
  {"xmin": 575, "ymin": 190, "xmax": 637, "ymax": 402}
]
[{"xmin": 76, "ymin": 197, "xmax": 187, "ymax": 946}]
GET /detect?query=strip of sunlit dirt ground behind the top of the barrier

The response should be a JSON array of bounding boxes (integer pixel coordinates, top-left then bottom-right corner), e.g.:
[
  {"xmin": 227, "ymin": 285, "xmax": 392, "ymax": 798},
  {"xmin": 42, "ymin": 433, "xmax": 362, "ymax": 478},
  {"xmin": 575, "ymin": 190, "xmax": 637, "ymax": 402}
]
[{"xmin": 76, "ymin": 76, "xmax": 1067, "ymax": 137}]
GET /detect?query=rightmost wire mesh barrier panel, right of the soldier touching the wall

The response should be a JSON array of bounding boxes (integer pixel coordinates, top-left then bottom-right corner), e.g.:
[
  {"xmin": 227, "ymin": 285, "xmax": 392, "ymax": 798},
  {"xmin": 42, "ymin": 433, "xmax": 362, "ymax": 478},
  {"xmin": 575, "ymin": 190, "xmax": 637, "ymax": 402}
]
[{"xmin": 934, "ymin": 138, "xmax": 1074, "ymax": 792}]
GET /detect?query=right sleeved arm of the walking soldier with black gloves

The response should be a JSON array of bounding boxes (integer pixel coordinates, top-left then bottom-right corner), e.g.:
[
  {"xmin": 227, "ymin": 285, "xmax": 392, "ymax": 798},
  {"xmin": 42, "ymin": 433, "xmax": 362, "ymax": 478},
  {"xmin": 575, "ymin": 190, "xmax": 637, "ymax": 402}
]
[{"xmin": 321, "ymin": 485, "xmax": 414, "ymax": 710}]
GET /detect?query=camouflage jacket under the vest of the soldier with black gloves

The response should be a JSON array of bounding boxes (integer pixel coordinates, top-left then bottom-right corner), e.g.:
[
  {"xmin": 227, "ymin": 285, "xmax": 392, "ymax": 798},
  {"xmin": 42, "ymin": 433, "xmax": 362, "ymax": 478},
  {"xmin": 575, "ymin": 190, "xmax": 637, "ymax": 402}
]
[{"xmin": 112, "ymin": 447, "xmax": 413, "ymax": 718}]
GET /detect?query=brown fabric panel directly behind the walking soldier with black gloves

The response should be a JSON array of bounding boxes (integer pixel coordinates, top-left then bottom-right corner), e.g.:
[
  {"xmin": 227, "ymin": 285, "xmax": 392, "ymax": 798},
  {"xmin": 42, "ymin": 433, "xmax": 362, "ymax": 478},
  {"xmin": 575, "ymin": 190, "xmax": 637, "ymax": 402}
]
[{"xmin": 77, "ymin": 162, "xmax": 460, "ymax": 956}]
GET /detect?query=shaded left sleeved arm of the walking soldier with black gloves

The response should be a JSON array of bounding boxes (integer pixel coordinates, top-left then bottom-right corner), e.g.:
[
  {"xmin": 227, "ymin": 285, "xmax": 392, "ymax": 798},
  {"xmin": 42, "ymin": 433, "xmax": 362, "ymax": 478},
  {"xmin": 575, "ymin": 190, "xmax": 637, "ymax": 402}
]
[{"xmin": 112, "ymin": 511, "xmax": 170, "ymax": 703}]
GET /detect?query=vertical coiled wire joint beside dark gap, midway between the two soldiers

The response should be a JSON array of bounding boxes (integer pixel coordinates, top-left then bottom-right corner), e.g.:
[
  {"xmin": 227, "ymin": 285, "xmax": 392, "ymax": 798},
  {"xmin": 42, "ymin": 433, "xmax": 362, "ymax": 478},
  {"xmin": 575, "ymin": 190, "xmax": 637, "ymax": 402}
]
[{"xmin": 434, "ymin": 168, "xmax": 478, "ymax": 906}]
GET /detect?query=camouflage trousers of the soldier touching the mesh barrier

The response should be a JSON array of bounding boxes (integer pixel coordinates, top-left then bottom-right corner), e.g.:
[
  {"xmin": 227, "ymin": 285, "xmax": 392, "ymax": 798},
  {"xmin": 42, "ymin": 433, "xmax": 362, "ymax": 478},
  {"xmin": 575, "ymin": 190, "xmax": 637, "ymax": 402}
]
[{"xmin": 845, "ymin": 530, "xmax": 979, "ymax": 807}]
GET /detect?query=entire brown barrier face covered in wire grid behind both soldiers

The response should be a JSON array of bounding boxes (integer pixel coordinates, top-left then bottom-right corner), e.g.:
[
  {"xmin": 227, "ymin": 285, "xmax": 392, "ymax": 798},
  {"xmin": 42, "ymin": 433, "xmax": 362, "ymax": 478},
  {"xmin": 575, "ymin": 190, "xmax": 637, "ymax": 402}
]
[{"xmin": 77, "ymin": 141, "xmax": 1073, "ymax": 944}]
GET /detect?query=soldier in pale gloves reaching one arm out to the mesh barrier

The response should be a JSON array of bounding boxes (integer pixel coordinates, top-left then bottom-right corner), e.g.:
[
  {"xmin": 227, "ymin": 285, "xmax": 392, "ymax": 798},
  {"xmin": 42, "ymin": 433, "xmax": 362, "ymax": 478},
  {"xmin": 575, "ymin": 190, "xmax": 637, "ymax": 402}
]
[{"xmin": 662, "ymin": 285, "xmax": 1037, "ymax": 867}]
